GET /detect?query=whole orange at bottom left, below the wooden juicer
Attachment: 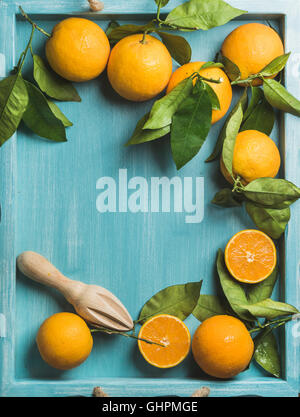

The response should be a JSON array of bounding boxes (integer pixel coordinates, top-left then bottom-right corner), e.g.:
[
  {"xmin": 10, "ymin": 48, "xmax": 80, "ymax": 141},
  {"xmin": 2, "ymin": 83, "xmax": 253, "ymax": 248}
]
[{"xmin": 36, "ymin": 313, "xmax": 93, "ymax": 369}]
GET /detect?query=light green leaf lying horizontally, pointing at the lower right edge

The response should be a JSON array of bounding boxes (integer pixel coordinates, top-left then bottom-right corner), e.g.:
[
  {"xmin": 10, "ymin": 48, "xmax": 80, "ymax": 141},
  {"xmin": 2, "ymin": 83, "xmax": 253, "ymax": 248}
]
[{"xmin": 241, "ymin": 298, "xmax": 299, "ymax": 320}]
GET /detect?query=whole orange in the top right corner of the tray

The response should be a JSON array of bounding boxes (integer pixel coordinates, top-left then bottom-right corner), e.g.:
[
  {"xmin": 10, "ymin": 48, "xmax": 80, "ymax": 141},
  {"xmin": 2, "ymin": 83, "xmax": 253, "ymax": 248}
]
[{"xmin": 221, "ymin": 23, "xmax": 284, "ymax": 85}]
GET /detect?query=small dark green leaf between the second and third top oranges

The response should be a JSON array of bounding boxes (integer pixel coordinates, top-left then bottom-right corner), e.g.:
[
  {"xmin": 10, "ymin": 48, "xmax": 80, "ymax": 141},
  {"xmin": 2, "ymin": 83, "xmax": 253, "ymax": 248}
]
[{"xmin": 157, "ymin": 32, "xmax": 192, "ymax": 65}]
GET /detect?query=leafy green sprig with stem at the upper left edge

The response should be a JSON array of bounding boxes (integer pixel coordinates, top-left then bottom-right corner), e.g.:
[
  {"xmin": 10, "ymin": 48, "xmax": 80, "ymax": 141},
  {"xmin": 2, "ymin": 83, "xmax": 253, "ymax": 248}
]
[{"xmin": 0, "ymin": 18, "xmax": 81, "ymax": 146}]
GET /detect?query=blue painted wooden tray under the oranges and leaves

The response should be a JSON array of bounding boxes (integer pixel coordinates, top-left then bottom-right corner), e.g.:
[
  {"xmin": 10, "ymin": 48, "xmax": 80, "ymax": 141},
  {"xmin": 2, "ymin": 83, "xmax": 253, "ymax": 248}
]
[{"xmin": 0, "ymin": 0, "xmax": 300, "ymax": 396}]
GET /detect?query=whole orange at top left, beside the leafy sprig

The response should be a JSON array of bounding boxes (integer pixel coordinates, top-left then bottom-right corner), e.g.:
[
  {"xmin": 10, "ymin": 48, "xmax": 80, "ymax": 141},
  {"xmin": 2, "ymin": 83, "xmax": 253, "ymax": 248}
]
[{"xmin": 46, "ymin": 17, "xmax": 110, "ymax": 82}]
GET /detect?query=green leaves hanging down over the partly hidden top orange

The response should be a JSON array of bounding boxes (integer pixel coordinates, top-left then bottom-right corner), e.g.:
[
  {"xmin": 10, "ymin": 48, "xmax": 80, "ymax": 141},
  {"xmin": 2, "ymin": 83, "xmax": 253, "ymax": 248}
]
[{"xmin": 126, "ymin": 72, "xmax": 220, "ymax": 169}]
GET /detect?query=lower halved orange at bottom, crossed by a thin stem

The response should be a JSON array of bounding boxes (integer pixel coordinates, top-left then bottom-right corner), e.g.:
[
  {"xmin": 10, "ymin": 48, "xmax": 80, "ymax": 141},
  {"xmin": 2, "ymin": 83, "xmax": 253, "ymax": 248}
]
[{"xmin": 138, "ymin": 314, "xmax": 191, "ymax": 368}]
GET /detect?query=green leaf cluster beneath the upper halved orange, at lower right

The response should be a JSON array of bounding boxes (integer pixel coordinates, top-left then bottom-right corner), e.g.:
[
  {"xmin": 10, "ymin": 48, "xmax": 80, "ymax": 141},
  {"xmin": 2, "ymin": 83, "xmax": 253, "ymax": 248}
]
[{"xmin": 193, "ymin": 249, "xmax": 299, "ymax": 378}]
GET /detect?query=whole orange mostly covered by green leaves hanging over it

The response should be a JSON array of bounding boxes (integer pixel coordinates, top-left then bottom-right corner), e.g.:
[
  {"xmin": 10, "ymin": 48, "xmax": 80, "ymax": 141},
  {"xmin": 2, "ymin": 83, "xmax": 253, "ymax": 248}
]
[{"xmin": 167, "ymin": 62, "xmax": 232, "ymax": 124}]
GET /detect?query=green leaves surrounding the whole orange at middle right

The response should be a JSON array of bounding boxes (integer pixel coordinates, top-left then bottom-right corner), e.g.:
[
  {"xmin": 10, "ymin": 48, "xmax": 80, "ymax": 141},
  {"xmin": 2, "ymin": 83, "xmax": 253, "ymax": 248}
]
[{"xmin": 210, "ymin": 82, "xmax": 300, "ymax": 239}]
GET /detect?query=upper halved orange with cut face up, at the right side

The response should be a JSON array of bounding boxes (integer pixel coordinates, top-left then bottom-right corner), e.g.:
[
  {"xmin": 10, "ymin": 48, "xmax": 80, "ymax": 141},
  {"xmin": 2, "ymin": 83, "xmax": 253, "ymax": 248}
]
[{"xmin": 225, "ymin": 229, "xmax": 276, "ymax": 284}]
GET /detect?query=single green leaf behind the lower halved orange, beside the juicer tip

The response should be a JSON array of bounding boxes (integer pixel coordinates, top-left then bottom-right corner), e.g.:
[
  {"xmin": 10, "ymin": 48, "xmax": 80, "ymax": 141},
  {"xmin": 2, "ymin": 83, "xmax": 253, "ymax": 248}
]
[{"xmin": 138, "ymin": 281, "xmax": 202, "ymax": 323}]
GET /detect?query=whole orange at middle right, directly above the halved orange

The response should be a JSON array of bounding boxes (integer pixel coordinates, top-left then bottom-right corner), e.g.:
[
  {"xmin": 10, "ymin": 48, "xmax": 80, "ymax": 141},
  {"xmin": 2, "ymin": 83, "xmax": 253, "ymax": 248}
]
[{"xmin": 220, "ymin": 130, "xmax": 280, "ymax": 184}]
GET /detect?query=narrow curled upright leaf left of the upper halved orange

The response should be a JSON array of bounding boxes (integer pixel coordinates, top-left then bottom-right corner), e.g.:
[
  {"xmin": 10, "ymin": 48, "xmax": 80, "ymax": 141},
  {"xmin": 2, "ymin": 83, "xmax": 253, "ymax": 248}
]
[{"xmin": 217, "ymin": 249, "xmax": 255, "ymax": 321}]
